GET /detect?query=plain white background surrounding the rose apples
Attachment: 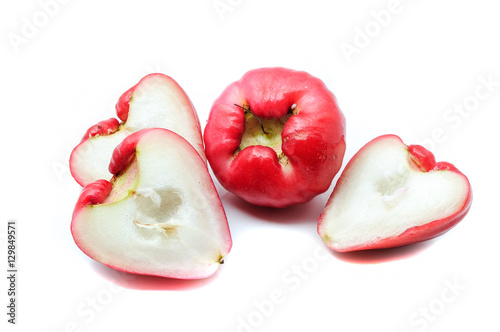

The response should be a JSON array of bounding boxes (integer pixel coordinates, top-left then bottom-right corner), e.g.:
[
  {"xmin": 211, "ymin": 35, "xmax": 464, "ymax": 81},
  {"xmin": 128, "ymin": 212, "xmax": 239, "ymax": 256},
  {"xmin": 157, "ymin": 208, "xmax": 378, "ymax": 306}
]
[{"xmin": 0, "ymin": 0, "xmax": 500, "ymax": 332}]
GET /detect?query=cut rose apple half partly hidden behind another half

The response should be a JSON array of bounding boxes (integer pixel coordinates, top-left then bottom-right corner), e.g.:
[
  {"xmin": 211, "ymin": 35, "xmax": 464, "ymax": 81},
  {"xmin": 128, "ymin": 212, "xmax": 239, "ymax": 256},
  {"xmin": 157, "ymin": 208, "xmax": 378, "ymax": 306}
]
[{"xmin": 70, "ymin": 73, "xmax": 205, "ymax": 186}]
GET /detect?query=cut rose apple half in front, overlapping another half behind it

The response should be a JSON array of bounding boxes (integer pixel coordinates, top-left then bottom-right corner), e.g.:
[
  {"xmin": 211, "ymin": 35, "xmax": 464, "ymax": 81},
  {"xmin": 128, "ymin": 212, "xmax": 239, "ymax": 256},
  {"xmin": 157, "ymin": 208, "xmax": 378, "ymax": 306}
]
[{"xmin": 71, "ymin": 128, "xmax": 232, "ymax": 279}]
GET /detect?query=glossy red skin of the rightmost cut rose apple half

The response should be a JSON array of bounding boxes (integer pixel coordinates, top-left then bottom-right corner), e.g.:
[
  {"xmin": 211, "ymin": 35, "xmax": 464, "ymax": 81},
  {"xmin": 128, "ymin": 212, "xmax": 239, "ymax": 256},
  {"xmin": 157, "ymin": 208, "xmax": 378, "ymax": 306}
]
[{"xmin": 318, "ymin": 135, "xmax": 472, "ymax": 252}]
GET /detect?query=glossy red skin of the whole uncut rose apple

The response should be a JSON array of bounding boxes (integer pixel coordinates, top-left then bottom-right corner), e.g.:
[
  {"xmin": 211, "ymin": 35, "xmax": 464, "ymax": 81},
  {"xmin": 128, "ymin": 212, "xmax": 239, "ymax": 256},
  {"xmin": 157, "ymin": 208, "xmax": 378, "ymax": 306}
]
[{"xmin": 204, "ymin": 68, "xmax": 345, "ymax": 207}]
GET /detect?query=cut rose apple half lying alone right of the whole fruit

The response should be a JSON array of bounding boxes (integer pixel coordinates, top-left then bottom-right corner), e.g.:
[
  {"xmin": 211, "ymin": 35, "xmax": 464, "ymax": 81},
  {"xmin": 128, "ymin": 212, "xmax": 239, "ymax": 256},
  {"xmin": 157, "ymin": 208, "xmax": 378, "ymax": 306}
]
[{"xmin": 318, "ymin": 135, "xmax": 472, "ymax": 252}]
